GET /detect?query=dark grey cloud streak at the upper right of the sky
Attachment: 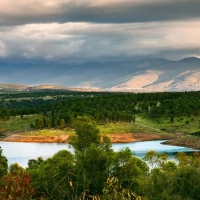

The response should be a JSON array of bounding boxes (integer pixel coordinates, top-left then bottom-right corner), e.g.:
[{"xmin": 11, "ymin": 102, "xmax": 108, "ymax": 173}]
[{"xmin": 57, "ymin": 0, "xmax": 200, "ymax": 23}]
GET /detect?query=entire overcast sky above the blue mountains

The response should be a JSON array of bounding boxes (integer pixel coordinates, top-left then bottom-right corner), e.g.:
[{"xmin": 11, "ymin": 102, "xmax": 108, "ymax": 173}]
[{"xmin": 0, "ymin": 0, "xmax": 200, "ymax": 62}]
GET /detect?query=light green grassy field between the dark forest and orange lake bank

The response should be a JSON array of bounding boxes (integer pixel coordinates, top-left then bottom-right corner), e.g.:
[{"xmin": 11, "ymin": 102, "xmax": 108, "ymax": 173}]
[{"xmin": 0, "ymin": 115, "xmax": 200, "ymax": 135}]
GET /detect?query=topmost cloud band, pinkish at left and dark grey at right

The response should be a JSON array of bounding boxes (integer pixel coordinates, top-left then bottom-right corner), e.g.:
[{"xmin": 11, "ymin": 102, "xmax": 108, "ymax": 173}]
[{"xmin": 0, "ymin": 0, "xmax": 200, "ymax": 25}]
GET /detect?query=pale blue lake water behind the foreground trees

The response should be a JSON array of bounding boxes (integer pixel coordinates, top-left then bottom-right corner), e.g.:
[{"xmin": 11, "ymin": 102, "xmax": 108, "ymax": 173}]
[{"xmin": 0, "ymin": 140, "xmax": 198, "ymax": 167}]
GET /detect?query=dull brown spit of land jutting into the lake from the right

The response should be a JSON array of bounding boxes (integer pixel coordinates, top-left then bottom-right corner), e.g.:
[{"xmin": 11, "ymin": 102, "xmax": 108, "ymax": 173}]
[{"xmin": 163, "ymin": 138, "xmax": 200, "ymax": 150}]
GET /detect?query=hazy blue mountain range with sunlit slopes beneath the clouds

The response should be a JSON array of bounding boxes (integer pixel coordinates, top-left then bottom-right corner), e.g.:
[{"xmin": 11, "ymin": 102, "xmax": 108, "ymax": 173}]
[{"xmin": 0, "ymin": 57, "xmax": 200, "ymax": 92}]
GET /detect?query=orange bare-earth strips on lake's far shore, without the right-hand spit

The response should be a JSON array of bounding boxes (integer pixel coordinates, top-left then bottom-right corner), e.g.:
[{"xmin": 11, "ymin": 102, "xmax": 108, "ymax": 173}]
[{"xmin": 2, "ymin": 133, "xmax": 174, "ymax": 143}]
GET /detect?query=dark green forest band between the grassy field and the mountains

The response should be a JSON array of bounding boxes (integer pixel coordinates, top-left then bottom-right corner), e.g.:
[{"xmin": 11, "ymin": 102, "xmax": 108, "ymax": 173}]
[{"xmin": 0, "ymin": 91, "xmax": 200, "ymax": 129}]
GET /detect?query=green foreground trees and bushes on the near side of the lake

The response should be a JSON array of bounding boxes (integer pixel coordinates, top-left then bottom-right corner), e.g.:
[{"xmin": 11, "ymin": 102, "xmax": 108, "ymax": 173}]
[{"xmin": 0, "ymin": 116, "xmax": 200, "ymax": 200}]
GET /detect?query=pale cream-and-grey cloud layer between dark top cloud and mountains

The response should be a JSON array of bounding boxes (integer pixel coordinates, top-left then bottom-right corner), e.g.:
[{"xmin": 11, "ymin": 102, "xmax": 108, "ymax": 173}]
[{"xmin": 0, "ymin": 20, "xmax": 200, "ymax": 61}]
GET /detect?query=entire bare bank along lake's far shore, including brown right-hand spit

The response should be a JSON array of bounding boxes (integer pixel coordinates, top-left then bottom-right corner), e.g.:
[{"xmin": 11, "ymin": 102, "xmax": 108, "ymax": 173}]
[{"xmin": 1, "ymin": 133, "xmax": 200, "ymax": 149}]
